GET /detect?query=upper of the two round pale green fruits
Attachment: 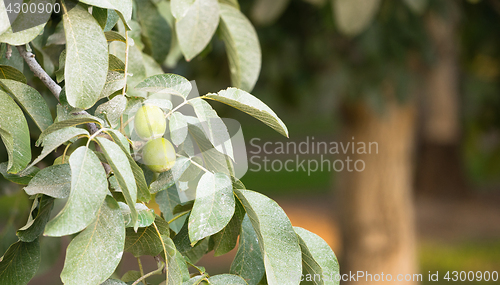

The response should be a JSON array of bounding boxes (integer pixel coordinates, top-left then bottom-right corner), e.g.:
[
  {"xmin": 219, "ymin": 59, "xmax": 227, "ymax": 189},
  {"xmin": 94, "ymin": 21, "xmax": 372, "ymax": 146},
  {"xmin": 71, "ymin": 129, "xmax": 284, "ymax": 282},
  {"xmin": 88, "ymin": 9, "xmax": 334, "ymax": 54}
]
[{"xmin": 134, "ymin": 104, "xmax": 167, "ymax": 140}]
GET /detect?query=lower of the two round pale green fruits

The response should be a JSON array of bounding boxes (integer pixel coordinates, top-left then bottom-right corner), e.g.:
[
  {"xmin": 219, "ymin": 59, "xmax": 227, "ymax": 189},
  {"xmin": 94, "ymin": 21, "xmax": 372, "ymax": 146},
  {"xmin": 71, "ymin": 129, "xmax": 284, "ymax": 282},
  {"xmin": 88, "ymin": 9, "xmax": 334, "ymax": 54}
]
[{"xmin": 142, "ymin": 138, "xmax": 176, "ymax": 172}]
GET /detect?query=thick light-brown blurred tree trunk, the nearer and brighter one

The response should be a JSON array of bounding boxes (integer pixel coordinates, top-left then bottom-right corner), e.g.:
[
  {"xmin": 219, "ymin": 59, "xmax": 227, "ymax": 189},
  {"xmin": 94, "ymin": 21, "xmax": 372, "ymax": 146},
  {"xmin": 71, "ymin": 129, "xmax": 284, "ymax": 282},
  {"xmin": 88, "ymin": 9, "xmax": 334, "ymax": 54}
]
[{"xmin": 338, "ymin": 98, "xmax": 418, "ymax": 285}]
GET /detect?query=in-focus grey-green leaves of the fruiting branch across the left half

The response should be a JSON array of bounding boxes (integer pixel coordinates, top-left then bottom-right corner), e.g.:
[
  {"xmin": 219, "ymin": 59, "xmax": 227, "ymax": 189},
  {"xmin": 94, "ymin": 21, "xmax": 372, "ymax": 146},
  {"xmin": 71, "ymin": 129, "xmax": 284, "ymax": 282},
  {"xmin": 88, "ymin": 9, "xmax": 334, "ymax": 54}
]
[{"xmin": 0, "ymin": 0, "xmax": 338, "ymax": 285}]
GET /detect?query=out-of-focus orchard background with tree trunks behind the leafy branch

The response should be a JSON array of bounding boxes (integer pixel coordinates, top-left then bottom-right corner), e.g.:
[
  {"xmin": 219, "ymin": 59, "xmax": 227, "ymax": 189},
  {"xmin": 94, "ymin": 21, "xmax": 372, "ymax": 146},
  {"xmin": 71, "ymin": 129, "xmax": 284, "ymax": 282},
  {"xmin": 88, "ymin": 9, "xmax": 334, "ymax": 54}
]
[{"xmin": 0, "ymin": 0, "xmax": 500, "ymax": 284}]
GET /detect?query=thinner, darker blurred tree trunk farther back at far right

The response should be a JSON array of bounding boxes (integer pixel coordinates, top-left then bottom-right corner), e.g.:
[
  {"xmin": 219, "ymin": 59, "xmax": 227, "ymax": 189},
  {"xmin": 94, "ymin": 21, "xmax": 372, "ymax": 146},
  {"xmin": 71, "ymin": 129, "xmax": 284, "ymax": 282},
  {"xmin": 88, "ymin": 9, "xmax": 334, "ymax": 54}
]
[{"xmin": 416, "ymin": 5, "xmax": 467, "ymax": 198}]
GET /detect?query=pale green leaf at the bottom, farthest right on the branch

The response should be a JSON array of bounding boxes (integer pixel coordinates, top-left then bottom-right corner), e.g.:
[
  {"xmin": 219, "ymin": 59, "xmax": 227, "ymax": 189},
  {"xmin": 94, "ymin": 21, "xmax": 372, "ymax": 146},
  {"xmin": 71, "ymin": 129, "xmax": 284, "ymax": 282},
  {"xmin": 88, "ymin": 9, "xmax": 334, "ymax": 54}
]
[{"xmin": 293, "ymin": 227, "xmax": 340, "ymax": 285}]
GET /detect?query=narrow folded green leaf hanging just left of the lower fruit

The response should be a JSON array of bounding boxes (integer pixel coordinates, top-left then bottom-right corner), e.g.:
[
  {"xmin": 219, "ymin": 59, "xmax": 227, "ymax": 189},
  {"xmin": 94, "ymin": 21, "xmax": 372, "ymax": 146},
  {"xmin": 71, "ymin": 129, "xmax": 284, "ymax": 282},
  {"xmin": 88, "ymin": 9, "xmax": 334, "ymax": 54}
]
[{"xmin": 108, "ymin": 130, "xmax": 151, "ymax": 202}]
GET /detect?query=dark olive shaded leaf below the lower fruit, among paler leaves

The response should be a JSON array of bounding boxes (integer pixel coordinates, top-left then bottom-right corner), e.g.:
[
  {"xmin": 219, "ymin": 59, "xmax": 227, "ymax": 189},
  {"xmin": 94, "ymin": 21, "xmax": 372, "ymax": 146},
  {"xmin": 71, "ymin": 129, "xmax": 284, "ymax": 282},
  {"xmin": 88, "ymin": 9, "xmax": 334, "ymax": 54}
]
[{"xmin": 125, "ymin": 215, "xmax": 169, "ymax": 257}]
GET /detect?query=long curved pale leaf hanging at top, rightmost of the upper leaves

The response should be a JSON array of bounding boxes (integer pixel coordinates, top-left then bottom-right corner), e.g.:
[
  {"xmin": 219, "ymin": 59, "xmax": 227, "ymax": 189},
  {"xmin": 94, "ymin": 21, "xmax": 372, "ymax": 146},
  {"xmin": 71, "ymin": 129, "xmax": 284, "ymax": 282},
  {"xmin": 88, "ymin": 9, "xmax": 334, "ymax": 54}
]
[{"xmin": 220, "ymin": 4, "xmax": 262, "ymax": 92}]
